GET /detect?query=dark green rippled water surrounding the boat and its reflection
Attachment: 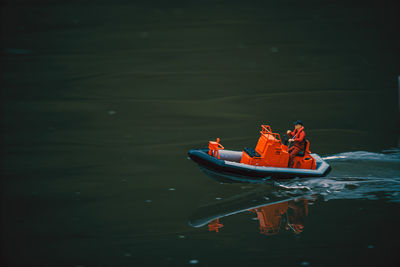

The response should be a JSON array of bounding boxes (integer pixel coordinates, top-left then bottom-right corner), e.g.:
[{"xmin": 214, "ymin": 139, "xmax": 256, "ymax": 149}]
[{"xmin": 1, "ymin": 0, "xmax": 400, "ymax": 266}]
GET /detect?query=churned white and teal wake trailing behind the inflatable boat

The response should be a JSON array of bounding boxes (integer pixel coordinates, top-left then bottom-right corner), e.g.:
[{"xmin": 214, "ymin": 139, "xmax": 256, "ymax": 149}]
[{"xmin": 276, "ymin": 148, "xmax": 400, "ymax": 202}]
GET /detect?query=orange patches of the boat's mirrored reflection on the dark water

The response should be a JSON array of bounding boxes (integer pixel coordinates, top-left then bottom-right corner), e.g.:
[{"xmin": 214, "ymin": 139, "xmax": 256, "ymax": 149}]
[{"xmin": 208, "ymin": 199, "xmax": 310, "ymax": 235}]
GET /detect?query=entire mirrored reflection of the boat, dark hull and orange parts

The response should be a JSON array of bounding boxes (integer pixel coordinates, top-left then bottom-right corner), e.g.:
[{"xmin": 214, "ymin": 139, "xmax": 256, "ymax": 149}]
[{"xmin": 189, "ymin": 187, "xmax": 315, "ymax": 235}]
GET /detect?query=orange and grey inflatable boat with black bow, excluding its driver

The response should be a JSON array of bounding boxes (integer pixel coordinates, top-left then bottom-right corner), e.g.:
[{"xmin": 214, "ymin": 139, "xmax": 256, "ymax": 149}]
[{"xmin": 188, "ymin": 125, "xmax": 331, "ymax": 183}]
